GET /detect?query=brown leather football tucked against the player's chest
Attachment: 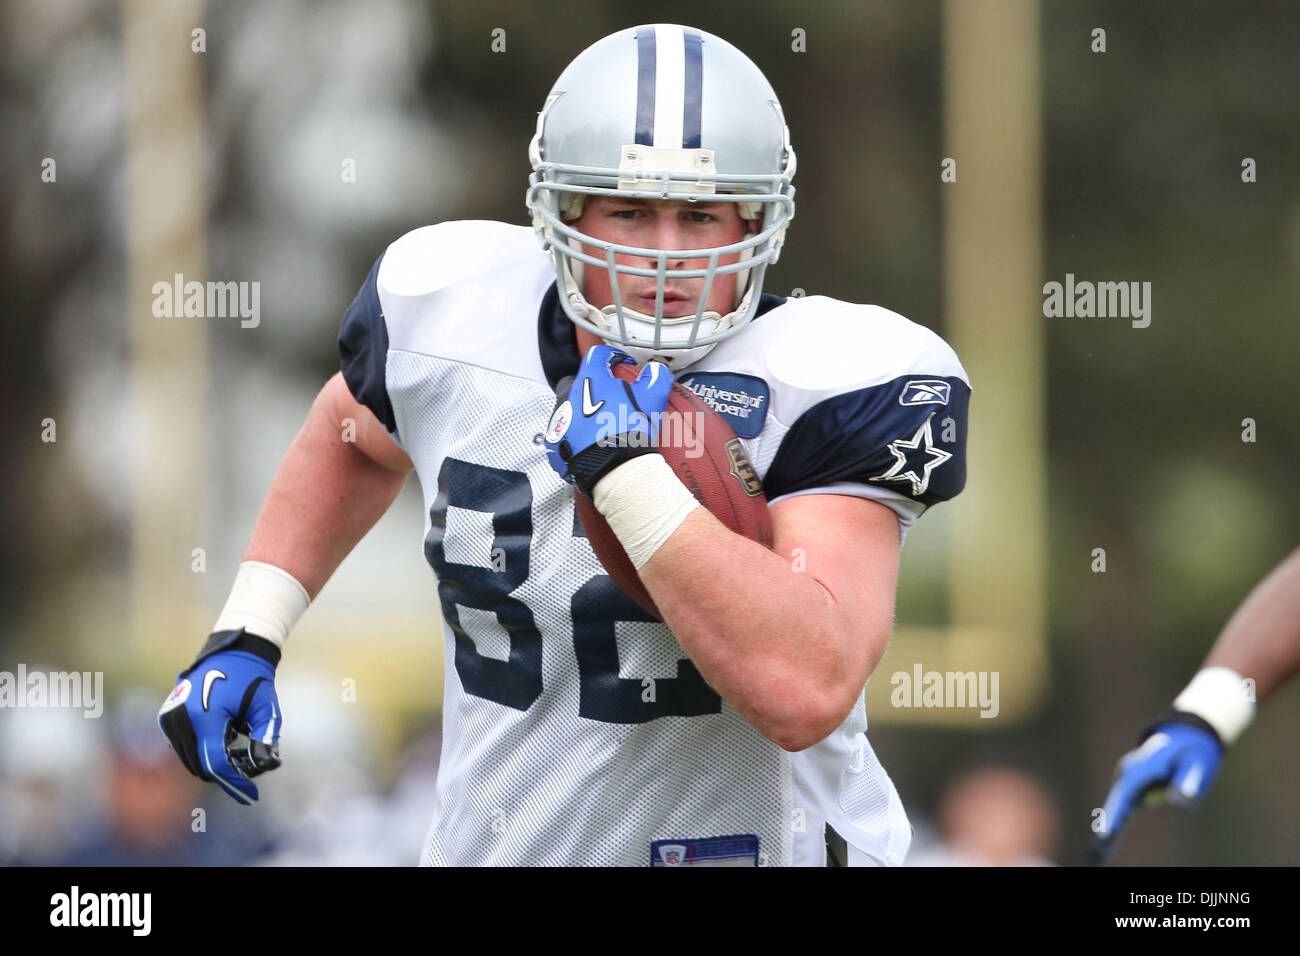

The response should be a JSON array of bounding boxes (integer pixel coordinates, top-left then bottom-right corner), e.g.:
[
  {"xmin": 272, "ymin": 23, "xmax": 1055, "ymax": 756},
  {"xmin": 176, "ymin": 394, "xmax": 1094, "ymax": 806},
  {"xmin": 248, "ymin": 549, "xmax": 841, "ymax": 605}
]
[{"xmin": 577, "ymin": 362, "xmax": 772, "ymax": 620}]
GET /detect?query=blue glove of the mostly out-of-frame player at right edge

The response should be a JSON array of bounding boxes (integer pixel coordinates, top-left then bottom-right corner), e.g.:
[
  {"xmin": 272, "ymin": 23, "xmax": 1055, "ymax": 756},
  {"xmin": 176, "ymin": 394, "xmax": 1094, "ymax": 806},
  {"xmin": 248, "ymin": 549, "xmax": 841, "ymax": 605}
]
[{"xmin": 1093, "ymin": 710, "xmax": 1223, "ymax": 862}]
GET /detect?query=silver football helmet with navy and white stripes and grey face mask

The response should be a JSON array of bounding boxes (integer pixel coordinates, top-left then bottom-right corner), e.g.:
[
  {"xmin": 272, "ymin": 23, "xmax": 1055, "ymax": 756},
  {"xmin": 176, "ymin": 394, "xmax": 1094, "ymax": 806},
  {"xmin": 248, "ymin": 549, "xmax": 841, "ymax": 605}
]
[{"xmin": 527, "ymin": 23, "xmax": 794, "ymax": 369}]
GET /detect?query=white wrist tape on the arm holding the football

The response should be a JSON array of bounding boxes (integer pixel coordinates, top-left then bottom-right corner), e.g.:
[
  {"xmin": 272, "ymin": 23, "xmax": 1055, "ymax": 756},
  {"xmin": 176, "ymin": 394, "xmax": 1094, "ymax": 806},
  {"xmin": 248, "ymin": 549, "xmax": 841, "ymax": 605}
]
[{"xmin": 592, "ymin": 455, "xmax": 699, "ymax": 571}]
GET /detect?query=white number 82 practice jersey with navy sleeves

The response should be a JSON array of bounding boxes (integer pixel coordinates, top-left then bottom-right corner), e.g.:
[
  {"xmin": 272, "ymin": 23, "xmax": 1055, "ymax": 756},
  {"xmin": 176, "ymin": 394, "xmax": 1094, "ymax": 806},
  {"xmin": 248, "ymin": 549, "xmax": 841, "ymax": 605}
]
[{"xmin": 339, "ymin": 221, "xmax": 970, "ymax": 866}]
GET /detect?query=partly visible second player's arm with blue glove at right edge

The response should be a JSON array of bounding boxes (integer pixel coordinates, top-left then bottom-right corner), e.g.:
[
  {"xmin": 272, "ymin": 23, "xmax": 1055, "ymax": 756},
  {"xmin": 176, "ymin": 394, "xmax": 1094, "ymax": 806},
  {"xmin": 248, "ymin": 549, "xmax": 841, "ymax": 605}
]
[{"xmin": 1092, "ymin": 550, "xmax": 1300, "ymax": 862}]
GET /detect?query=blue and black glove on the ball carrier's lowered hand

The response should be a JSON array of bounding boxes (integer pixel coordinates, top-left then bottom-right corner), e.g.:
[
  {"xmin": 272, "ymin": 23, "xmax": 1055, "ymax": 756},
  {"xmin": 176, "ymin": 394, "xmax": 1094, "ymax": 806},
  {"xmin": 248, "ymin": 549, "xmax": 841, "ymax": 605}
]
[{"xmin": 159, "ymin": 628, "xmax": 281, "ymax": 804}]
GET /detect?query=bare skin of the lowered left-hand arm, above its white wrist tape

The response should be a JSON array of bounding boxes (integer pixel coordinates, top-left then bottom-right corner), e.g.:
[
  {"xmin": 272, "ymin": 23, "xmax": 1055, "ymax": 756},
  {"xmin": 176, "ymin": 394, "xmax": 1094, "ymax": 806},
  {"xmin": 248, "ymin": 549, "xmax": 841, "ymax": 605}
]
[{"xmin": 244, "ymin": 378, "xmax": 410, "ymax": 600}]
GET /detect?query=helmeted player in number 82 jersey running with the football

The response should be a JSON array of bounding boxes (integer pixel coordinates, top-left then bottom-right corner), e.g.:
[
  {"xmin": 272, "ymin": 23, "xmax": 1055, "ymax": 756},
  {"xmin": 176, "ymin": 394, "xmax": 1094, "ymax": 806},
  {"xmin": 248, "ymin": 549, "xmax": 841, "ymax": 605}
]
[{"xmin": 160, "ymin": 23, "xmax": 970, "ymax": 866}]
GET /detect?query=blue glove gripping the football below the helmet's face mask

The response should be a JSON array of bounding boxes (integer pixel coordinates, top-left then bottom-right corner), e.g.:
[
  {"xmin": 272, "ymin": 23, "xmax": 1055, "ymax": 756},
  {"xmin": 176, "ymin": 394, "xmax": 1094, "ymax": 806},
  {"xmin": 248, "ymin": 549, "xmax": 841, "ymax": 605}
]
[{"xmin": 545, "ymin": 345, "xmax": 672, "ymax": 497}]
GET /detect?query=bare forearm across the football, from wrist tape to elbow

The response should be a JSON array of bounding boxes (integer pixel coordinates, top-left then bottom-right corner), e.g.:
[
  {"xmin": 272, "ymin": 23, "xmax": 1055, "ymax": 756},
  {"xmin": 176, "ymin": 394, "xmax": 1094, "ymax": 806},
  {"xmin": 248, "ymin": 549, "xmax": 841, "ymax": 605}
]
[{"xmin": 640, "ymin": 509, "xmax": 873, "ymax": 750}]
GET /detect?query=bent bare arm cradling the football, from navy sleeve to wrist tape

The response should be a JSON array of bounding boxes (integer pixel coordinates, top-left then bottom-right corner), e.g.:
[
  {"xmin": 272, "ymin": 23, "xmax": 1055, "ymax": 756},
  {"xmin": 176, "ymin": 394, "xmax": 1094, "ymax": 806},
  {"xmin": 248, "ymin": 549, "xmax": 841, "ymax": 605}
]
[{"xmin": 641, "ymin": 494, "xmax": 900, "ymax": 750}]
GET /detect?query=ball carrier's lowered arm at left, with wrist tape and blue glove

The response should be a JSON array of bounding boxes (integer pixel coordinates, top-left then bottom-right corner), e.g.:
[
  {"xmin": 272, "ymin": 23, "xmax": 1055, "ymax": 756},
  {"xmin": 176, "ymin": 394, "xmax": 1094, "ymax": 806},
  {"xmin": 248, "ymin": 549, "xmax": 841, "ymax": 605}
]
[{"xmin": 159, "ymin": 375, "xmax": 412, "ymax": 804}]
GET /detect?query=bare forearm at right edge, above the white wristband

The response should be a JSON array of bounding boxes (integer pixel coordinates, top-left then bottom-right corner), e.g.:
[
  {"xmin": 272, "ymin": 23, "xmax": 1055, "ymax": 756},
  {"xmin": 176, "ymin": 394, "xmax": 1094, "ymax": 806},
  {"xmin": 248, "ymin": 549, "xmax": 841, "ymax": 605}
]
[{"xmin": 1205, "ymin": 550, "xmax": 1300, "ymax": 702}]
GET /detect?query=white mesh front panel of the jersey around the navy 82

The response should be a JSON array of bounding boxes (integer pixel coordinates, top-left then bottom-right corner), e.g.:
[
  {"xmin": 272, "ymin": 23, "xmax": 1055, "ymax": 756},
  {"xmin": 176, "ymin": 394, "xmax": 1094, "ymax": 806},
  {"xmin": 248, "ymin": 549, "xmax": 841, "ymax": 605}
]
[{"xmin": 387, "ymin": 351, "xmax": 793, "ymax": 865}]
